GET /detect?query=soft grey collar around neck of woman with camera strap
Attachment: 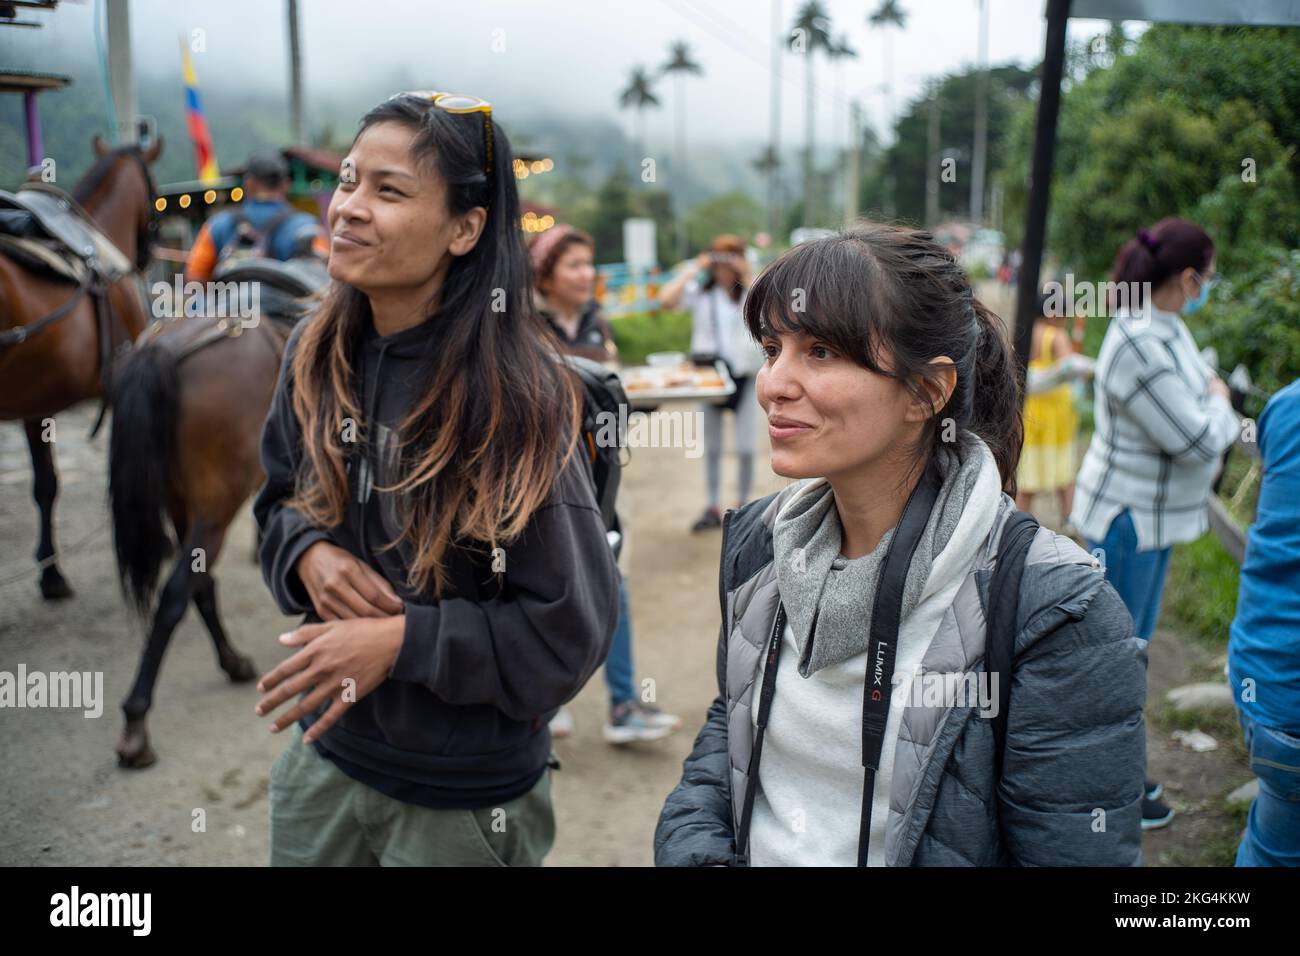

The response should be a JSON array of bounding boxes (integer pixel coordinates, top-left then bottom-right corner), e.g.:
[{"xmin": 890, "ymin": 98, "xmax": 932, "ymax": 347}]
[{"xmin": 772, "ymin": 442, "xmax": 982, "ymax": 678}]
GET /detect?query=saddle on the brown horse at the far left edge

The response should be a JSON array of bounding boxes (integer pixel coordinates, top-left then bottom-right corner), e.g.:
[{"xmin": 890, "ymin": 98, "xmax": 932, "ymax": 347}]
[{"xmin": 0, "ymin": 179, "xmax": 133, "ymax": 286}]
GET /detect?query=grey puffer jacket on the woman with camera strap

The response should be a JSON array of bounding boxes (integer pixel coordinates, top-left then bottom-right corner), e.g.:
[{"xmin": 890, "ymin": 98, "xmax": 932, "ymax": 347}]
[{"xmin": 654, "ymin": 470, "xmax": 1147, "ymax": 866}]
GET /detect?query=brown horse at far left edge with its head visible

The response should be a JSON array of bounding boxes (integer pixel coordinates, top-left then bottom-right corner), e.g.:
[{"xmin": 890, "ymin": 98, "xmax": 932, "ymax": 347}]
[{"xmin": 0, "ymin": 137, "xmax": 163, "ymax": 600}]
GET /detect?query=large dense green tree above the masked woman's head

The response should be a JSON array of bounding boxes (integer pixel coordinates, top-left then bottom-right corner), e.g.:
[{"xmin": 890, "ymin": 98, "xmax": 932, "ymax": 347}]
[{"xmin": 1000, "ymin": 25, "xmax": 1300, "ymax": 269}]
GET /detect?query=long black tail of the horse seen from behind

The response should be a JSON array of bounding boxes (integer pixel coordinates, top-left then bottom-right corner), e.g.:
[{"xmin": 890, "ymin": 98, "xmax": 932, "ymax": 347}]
[{"xmin": 108, "ymin": 345, "xmax": 178, "ymax": 614}]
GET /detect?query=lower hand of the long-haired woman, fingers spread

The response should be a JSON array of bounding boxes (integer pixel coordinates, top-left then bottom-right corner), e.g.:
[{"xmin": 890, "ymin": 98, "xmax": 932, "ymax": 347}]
[{"xmin": 254, "ymin": 614, "xmax": 406, "ymax": 744}]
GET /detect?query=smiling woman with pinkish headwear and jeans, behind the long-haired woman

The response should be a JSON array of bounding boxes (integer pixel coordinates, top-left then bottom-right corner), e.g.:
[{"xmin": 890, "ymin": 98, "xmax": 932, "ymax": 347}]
[{"xmin": 528, "ymin": 224, "xmax": 683, "ymax": 744}]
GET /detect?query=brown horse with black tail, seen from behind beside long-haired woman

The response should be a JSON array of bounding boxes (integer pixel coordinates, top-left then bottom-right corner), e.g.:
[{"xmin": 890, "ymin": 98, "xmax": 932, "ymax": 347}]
[{"xmin": 109, "ymin": 268, "xmax": 324, "ymax": 767}]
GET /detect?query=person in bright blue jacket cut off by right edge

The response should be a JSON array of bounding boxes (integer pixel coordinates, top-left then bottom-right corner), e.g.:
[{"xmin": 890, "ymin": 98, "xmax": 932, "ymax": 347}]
[{"xmin": 1227, "ymin": 378, "xmax": 1300, "ymax": 866}]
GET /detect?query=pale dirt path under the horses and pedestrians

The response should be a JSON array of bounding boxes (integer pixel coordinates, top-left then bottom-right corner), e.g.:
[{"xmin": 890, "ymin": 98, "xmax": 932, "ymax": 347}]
[{"xmin": 0, "ymin": 406, "xmax": 1244, "ymax": 866}]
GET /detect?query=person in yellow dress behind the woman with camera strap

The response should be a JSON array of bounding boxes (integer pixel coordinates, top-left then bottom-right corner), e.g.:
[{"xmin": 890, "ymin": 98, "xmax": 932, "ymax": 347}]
[{"xmin": 1015, "ymin": 297, "xmax": 1079, "ymax": 533}]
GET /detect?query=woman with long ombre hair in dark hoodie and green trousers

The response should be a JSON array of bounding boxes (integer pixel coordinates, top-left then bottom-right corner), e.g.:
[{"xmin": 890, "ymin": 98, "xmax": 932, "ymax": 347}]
[{"xmin": 255, "ymin": 94, "xmax": 619, "ymax": 865}]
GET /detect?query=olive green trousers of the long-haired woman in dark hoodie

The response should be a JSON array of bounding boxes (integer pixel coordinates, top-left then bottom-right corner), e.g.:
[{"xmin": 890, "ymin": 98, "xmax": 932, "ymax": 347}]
[{"xmin": 270, "ymin": 727, "xmax": 555, "ymax": 866}]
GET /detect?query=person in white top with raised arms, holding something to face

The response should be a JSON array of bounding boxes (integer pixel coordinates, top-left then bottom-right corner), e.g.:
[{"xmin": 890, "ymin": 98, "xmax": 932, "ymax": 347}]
[{"xmin": 659, "ymin": 234, "xmax": 763, "ymax": 532}]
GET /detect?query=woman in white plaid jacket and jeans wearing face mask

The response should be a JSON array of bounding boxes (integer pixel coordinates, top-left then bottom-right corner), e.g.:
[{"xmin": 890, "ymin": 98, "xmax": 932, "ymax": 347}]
[{"xmin": 1070, "ymin": 217, "xmax": 1242, "ymax": 829}]
